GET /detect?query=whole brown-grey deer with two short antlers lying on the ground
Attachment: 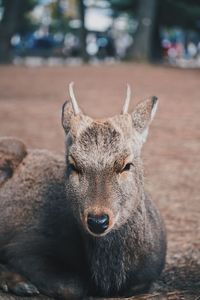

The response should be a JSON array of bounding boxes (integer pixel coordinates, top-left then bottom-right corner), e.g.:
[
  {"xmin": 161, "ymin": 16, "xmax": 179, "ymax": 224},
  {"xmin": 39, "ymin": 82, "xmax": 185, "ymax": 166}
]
[{"xmin": 0, "ymin": 83, "xmax": 166, "ymax": 300}]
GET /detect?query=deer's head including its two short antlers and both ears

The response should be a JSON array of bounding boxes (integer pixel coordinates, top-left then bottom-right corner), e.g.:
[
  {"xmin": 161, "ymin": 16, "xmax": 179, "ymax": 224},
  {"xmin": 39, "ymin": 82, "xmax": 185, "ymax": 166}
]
[{"xmin": 62, "ymin": 85, "xmax": 157, "ymax": 236}]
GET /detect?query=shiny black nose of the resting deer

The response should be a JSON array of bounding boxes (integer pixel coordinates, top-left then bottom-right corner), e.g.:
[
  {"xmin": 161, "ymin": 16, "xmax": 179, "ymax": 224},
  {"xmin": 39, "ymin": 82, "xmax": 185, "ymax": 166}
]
[{"xmin": 87, "ymin": 214, "xmax": 109, "ymax": 234}]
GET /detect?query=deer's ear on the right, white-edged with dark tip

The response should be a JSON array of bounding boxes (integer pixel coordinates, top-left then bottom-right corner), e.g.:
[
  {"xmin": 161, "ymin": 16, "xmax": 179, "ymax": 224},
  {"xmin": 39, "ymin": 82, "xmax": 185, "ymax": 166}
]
[{"xmin": 132, "ymin": 96, "xmax": 158, "ymax": 143}]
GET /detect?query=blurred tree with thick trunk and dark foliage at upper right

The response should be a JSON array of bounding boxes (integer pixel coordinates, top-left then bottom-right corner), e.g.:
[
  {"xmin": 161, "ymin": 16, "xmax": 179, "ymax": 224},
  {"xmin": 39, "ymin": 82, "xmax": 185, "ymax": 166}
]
[{"xmin": 110, "ymin": 0, "xmax": 200, "ymax": 60}]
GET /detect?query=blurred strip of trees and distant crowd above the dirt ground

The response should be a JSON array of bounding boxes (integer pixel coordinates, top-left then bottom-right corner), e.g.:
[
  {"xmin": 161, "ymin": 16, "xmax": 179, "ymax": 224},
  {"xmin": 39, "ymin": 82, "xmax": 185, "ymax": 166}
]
[{"xmin": 0, "ymin": 0, "xmax": 200, "ymax": 67}]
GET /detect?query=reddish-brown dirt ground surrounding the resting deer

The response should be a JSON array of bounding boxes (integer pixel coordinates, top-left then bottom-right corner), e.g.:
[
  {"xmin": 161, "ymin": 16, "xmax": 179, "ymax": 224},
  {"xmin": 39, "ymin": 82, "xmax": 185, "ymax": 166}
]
[{"xmin": 0, "ymin": 64, "xmax": 200, "ymax": 300}]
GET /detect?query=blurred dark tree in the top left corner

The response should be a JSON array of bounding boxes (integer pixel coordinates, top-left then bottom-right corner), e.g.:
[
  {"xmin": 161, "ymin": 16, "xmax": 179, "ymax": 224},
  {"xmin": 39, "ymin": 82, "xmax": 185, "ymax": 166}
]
[{"xmin": 0, "ymin": 0, "xmax": 36, "ymax": 63}]
